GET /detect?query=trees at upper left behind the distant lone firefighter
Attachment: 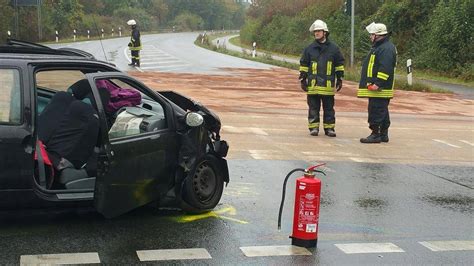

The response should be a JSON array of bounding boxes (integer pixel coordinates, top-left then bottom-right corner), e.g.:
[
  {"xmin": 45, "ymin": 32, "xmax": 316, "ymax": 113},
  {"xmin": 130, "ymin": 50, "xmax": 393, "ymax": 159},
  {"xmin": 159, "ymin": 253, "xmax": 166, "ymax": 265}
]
[{"xmin": 0, "ymin": 0, "xmax": 245, "ymax": 41}]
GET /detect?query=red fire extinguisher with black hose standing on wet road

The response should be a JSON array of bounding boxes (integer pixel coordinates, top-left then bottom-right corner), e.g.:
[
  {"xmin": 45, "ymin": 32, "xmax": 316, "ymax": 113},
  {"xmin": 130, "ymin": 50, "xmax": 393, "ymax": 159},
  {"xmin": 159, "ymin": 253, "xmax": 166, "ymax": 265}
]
[{"xmin": 278, "ymin": 163, "xmax": 326, "ymax": 248}]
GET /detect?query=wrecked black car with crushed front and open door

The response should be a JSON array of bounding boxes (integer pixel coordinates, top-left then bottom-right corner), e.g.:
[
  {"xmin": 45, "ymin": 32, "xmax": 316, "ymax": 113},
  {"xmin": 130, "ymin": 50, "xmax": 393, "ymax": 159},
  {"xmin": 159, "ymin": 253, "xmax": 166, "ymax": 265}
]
[{"xmin": 0, "ymin": 40, "xmax": 229, "ymax": 217}]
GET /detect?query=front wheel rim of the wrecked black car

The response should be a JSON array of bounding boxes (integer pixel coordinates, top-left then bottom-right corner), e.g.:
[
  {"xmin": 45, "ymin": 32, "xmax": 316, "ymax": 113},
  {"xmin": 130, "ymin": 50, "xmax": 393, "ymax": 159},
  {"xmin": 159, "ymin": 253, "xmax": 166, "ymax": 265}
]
[{"xmin": 193, "ymin": 163, "xmax": 217, "ymax": 202}]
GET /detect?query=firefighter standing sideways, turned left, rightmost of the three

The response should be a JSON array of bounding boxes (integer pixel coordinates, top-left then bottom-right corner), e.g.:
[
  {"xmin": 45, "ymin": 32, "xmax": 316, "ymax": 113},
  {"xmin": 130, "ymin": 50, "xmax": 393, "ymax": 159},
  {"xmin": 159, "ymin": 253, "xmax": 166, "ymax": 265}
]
[{"xmin": 357, "ymin": 22, "xmax": 397, "ymax": 143}]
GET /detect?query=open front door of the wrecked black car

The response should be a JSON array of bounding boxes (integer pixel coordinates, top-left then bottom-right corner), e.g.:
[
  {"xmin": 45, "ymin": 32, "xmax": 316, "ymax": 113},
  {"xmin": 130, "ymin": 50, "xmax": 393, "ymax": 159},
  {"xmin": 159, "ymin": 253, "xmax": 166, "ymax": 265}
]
[{"xmin": 86, "ymin": 73, "xmax": 177, "ymax": 217}]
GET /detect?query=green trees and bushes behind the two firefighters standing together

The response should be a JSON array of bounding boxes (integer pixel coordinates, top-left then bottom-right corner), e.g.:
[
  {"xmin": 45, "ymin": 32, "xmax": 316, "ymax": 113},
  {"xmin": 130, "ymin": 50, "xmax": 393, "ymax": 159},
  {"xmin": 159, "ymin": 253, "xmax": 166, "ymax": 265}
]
[{"xmin": 241, "ymin": 0, "xmax": 474, "ymax": 81}]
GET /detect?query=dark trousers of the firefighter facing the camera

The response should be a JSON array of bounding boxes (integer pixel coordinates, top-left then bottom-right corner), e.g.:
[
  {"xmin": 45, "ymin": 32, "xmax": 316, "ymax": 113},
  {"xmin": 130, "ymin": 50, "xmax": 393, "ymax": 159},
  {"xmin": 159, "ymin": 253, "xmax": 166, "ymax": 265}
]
[{"xmin": 307, "ymin": 95, "xmax": 336, "ymax": 130}]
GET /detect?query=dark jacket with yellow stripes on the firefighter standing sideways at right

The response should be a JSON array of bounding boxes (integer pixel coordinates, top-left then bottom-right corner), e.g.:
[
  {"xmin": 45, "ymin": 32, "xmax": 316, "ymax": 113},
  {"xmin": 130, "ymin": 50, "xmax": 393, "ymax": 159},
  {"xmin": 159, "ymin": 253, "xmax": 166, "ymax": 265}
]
[{"xmin": 357, "ymin": 36, "xmax": 397, "ymax": 99}]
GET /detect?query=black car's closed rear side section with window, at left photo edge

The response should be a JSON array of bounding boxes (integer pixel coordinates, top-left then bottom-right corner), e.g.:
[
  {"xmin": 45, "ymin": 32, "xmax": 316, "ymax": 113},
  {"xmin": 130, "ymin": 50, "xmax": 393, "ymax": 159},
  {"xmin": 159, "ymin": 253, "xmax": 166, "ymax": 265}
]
[{"xmin": 0, "ymin": 65, "xmax": 34, "ymax": 193}]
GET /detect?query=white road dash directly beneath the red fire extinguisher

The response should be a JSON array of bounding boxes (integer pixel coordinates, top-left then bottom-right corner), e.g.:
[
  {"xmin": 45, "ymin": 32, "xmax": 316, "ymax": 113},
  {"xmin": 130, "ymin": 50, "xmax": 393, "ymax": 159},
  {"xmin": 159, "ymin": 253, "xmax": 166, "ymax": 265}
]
[{"xmin": 240, "ymin": 246, "xmax": 312, "ymax": 257}]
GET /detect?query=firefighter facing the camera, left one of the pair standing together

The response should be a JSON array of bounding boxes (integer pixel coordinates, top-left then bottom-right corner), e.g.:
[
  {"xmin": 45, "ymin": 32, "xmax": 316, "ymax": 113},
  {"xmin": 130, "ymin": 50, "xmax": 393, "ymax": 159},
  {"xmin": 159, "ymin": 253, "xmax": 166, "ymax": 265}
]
[{"xmin": 299, "ymin": 19, "xmax": 344, "ymax": 137}]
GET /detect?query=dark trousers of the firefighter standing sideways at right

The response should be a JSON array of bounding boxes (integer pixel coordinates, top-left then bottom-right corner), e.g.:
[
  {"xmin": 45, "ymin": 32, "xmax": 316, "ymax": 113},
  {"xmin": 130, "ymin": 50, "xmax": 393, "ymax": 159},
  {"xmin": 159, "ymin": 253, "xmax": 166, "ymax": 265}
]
[{"xmin": 368, "ymin": 98, "xmax": 390, "ymax": 131}]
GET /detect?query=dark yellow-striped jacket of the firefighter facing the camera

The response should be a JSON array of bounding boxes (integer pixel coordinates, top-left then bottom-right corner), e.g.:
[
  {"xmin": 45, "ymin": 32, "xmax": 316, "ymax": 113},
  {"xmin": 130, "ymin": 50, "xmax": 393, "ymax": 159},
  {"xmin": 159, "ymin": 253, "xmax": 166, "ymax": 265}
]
[{"xmin": 300, "ymin": 39, "xmax": 344, "ymax": 95}]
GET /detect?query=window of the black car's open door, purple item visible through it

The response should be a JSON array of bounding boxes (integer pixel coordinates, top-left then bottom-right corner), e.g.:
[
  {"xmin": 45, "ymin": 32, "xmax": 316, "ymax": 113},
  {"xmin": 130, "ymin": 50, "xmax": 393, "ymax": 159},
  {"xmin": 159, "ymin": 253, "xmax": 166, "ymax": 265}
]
[{"xmin": 96, "ymin": 78, "xmax": 167, "ymax": 139}]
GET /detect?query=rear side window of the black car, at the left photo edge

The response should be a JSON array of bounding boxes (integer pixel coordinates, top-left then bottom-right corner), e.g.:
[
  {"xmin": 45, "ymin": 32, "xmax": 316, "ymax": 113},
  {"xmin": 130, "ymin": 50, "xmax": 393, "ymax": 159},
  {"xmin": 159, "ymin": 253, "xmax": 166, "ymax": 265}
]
[{"xmin": 0, "ymin": 69, "xmax": 22, "ymax": 124}]
